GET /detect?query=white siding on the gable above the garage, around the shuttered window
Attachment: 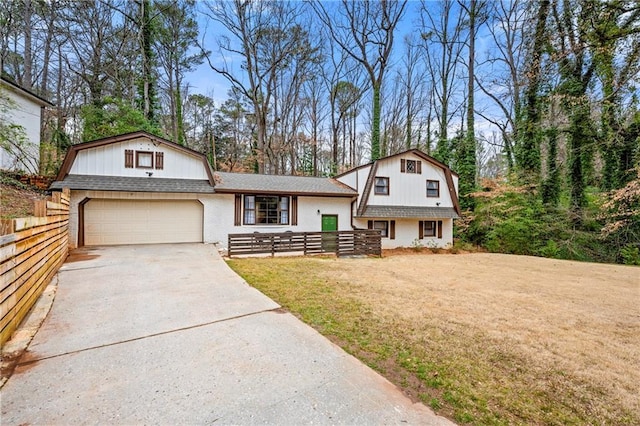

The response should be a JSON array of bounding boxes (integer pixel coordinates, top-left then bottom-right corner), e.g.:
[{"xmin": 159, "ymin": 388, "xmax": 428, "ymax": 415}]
[{"xmin": 69, "ymin": 137, "xmax": 208, "ymax": 179}]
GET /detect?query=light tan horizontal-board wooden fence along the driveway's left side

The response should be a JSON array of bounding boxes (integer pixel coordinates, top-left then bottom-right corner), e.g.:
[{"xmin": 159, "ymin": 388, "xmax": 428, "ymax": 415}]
[{"xmin": 0, "ymin": 190, "xmax": 69, "ymax": 344}]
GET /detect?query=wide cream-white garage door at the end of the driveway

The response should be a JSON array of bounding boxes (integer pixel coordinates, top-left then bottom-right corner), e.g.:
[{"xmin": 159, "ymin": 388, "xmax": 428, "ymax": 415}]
[{"xmin": 84, "ymin": 199, "xmax": 203, "ymax": 246}]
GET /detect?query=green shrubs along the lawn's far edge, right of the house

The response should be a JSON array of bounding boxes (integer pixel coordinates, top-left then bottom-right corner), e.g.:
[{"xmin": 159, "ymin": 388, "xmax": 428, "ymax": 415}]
[{"xmin": 456, "ymin": 180, "xmax": 624, "ymax": 262}]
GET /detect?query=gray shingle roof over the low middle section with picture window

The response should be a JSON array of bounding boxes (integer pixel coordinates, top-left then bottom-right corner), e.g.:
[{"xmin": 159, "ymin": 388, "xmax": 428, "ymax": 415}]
[{"xmin": 214, "ymin": 172, "xmax": 357, "ymax": 197}]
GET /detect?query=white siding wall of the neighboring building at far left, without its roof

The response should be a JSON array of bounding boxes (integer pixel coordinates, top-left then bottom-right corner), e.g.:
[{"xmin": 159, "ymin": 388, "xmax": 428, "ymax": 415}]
[{"xmin": 0, "ymin": 85, "xmax": 42, "ymax": 174}]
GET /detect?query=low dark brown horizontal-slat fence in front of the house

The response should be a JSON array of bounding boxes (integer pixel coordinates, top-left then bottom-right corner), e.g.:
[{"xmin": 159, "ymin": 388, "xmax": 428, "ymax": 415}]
[{"xmin": 228, "ymin": 229, "xmax": 382, "ymax": 257}]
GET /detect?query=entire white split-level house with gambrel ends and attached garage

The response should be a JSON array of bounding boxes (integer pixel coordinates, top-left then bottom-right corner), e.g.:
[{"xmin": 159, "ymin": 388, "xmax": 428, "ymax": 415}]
[{"xmin": 51, "ymin": 132, "xmax": 457, "ymax": 248}]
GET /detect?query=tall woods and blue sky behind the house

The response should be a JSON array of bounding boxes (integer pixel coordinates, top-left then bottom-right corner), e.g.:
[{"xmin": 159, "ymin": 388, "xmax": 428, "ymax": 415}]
[{"xmin": 0, "ymin": 0, "xmax": 640, "ymax": 263}]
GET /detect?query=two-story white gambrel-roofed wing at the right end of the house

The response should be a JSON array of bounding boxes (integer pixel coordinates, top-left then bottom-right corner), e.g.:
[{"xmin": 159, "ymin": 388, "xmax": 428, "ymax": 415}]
[{"xmin": 336, "ymin": 149, "xmax": 460, "ymax": 248}]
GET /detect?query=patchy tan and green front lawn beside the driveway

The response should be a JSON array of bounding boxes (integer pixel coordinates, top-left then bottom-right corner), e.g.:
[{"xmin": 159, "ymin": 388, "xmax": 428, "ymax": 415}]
[{"xmin": 229, "ymin": 253, "xmax": 640, "ymax": 424}]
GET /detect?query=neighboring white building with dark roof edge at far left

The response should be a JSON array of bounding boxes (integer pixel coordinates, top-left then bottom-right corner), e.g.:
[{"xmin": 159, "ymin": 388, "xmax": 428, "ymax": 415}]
[{"xmin": 0, "ymin": 78, "xmax": 53, "ymax": 174}]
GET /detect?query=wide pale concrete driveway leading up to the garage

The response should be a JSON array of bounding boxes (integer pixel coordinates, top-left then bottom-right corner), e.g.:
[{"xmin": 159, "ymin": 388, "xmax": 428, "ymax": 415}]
[{"xmin": 0, "ymin": 244, "xmax": 450, "ymax": 425}]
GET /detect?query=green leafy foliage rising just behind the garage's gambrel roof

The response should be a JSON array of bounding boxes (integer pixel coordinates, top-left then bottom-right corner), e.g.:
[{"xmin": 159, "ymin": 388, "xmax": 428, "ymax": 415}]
[{"xmin": 80, "ymin": 97, "xmax": 162, "ymax": 141}]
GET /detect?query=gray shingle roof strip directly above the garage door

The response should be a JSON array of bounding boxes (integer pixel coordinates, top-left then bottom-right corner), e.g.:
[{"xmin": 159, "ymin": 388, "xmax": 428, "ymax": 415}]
[{"xmin": 50, "ymin": 175, "xmax": 214, "ymax": 193}]
